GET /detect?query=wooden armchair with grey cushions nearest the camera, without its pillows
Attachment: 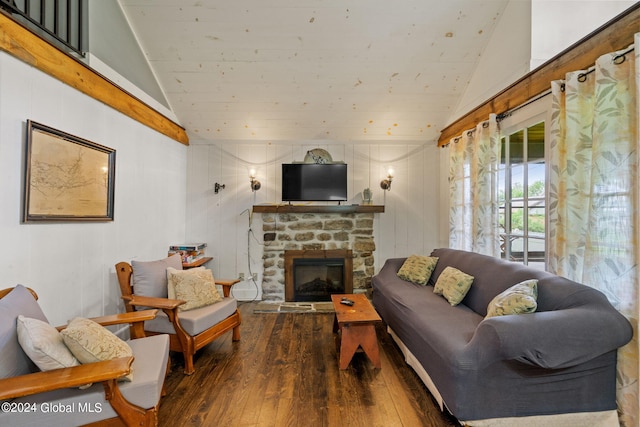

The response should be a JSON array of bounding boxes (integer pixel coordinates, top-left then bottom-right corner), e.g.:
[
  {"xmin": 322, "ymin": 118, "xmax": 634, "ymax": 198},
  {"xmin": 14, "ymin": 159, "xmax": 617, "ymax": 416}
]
[{"xmin": 0, "ymin": 286, "xmax": 169, "ymax": 426}]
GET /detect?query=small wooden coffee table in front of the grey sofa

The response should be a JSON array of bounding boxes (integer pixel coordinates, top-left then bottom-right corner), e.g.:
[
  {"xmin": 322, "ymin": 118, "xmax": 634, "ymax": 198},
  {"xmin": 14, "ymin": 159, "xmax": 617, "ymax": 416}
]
[{"xmin": 331, "ymin": 294, "xmax": 382, "ymax": 369}]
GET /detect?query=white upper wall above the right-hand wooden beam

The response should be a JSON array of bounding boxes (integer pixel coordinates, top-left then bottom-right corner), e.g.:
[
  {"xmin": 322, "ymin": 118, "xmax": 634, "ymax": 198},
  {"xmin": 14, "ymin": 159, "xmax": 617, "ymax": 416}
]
[{"xmin": 449, "ymin": 0, "xmax": 636, "ymax": 123}]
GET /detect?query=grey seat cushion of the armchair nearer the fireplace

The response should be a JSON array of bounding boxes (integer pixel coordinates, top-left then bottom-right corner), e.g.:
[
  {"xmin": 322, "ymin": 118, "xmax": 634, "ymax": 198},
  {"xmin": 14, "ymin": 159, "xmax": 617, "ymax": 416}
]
[{"xmin": 144, "ymin": 298, "xmax": 238, "ymax": 336}]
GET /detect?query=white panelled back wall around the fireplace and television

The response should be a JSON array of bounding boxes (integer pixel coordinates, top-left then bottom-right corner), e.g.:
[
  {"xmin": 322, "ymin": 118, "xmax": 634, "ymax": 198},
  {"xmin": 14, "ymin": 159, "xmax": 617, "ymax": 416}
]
[{"xmin": 186, "ymin": 141, "xmax": 446, "ymax": 299}]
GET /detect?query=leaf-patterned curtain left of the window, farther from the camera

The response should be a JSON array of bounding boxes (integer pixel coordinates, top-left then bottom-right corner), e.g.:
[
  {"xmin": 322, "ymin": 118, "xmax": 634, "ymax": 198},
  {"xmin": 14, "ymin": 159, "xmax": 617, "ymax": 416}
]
[{"xmin": 449, "ymin": 114, "xmax": 500, "ymax": 257}]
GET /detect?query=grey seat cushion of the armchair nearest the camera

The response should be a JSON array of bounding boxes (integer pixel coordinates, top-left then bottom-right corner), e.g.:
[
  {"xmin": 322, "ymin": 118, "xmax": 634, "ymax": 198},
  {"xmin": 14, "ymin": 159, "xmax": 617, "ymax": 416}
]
[{"xmin": 0, "ymin": 335, "xmax": 169, "ymax": 427}]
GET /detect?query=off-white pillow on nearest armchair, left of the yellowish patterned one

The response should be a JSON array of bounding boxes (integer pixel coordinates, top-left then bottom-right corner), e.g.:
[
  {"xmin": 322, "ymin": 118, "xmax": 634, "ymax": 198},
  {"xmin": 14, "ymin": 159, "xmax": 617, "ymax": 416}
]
[{"xmin": 17, "ymin": 315, "xmax": 80, "ymax": 371}]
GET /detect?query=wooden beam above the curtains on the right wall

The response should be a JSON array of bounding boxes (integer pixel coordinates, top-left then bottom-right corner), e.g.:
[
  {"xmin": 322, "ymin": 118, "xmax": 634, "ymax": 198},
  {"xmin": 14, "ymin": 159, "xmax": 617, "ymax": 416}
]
[{"xmin": 438, "ymin": 2, "xmax": 640, "ymax": 147}]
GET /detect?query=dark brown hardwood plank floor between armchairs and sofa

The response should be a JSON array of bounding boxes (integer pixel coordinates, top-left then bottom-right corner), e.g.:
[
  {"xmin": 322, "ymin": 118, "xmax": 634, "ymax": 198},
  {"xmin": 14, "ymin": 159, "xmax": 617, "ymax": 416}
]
[{"xmin": 159, "ymin": 303, "xmax": 458, "ymax": 427}]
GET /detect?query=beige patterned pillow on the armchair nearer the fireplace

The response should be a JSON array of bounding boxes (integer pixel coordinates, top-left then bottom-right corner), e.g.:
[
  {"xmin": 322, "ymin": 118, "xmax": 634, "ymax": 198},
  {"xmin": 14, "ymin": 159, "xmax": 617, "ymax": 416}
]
[{"xmin": 167, "ymin": 268, "xmax": 222, "ymax": 311}]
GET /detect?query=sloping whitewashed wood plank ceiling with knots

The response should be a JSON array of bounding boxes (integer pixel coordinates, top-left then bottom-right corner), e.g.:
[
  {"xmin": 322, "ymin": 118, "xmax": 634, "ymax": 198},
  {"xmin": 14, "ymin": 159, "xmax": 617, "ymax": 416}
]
[{"xmin": 120, "ymin": 0, "xmax": 508, "ymax": 142}]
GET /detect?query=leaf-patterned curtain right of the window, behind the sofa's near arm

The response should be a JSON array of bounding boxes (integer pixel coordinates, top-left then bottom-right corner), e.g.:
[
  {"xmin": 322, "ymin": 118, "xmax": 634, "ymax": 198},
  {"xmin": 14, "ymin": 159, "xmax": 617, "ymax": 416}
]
[{"xmin": 548, "ymin": 33, "xmax": 640, "ymax": 426}]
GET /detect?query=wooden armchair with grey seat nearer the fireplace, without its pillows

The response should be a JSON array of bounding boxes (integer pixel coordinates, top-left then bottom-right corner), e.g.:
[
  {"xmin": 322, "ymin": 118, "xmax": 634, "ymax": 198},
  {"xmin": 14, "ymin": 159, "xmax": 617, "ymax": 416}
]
[{"xmin": 116, "ymin": 256, "xmax": 241, "ymax": 375}]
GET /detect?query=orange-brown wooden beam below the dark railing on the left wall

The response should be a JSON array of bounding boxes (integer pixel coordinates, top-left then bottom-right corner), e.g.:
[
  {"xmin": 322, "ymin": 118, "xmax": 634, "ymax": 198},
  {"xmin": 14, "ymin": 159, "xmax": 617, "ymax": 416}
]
[{"xmin": 0, "ymin": 13, "xmax": 189, "ymax": 145}]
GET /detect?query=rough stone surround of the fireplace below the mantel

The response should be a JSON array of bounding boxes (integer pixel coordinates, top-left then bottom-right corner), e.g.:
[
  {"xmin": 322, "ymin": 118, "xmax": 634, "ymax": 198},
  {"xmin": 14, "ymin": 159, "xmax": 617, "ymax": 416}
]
[{"xmin": 262, "ymin": 213, "xmax": 376, "ymax": 301}]
